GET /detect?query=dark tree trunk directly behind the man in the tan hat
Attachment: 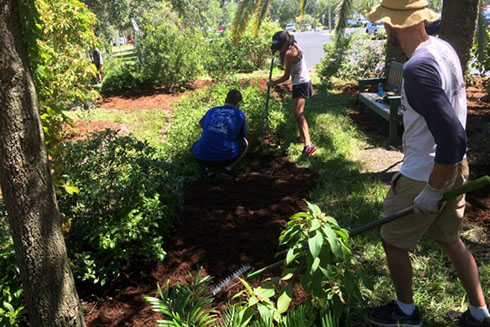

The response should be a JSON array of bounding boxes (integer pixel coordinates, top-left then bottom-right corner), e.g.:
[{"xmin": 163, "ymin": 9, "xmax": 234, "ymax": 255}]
[{"xmin": 439, "ymin": 0, "xmax": 480, "ymax": 76}]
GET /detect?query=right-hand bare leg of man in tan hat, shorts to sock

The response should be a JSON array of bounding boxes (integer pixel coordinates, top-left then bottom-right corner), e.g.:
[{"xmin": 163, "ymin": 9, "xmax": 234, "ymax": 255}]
[{"xmin": 437, "ymin": 239, "xmax": 485, "ymax": 307}]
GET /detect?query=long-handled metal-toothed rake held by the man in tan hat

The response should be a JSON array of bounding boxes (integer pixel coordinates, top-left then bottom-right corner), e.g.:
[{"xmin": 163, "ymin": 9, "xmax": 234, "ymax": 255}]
[{"xmin": 212, "ymin": 176, "xmax": 490, "ymax": 295}]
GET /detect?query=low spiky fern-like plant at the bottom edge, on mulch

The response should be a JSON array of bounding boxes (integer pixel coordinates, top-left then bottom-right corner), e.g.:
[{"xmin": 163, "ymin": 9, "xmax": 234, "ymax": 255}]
[{"xmin": 145, "ymin": 269, "xmax": 216, "ymax": 327}]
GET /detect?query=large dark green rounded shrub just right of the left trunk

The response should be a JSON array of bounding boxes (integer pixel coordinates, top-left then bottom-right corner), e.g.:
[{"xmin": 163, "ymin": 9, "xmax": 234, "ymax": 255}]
[{"xmin": 59, "ymin": 130, "xmax": 180, "ymax": 285}]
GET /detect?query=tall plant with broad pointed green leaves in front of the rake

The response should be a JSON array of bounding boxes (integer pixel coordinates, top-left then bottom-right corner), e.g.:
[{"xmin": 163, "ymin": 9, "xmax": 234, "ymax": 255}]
[{"xmin": 277, "ymin": 202, "xmax": 369, "ymax": 323}]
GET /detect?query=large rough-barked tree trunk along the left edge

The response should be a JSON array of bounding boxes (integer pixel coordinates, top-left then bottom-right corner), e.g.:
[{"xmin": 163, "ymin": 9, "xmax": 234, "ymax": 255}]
[{"xmin": 0, "ymin": 0, "xmax": 85, "ymax": 327}]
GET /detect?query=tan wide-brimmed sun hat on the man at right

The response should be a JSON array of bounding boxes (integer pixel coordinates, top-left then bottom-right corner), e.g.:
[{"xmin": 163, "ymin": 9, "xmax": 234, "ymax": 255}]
[{"xmin": 366, "ymin": 0, "xmax": 439, "ymax": 28}]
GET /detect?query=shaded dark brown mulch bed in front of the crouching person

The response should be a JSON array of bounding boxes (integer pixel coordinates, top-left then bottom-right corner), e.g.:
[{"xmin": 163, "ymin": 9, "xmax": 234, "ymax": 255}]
[{"xmin": 85, "ymin": 153, "xmax": 313, "ymax": 327}]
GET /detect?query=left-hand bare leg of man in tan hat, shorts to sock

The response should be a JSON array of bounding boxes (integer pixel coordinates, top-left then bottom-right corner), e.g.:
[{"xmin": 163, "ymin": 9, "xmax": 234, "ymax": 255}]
[{"xmin": 383, "ymin": 241, "xmax": 413, "ymax": 304}]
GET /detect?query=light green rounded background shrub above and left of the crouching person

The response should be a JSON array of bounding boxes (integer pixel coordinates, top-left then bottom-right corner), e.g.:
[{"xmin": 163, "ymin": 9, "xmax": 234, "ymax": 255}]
[{"xmin": 136, "ymin": 22, "xmax": 204, "ymax": 91}]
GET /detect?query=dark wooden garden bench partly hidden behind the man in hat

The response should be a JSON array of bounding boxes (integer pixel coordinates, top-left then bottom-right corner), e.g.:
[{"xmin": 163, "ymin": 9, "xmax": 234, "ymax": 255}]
[{"xmin": 358, "ymin": 61, "xmax": 403, "ymax": 144}]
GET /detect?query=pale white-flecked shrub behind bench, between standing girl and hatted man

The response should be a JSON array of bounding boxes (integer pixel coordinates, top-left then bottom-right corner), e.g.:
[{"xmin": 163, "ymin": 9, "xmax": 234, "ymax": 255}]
[{"xmin": 317, "ymin": 33, "xmax": 385, "ymax": 82}]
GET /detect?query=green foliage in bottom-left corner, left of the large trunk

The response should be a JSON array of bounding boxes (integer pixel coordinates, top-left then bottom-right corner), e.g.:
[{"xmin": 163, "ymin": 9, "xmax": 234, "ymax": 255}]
[{"xmin": 0, "ymin": 204, "xmax": 27, "ymax": 327}]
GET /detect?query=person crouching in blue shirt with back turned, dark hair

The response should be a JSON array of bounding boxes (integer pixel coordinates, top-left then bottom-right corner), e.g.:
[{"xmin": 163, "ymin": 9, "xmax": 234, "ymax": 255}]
[{"xmin": 192, "ymin": 90, "xmax": 248, "ymax": 171}]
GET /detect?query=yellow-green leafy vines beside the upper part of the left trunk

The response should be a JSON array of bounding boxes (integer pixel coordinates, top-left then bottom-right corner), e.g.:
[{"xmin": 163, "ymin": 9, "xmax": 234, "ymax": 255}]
[{"xmin": 19, "ymin": 0, "xmax": 98, "ymax": 195}]
